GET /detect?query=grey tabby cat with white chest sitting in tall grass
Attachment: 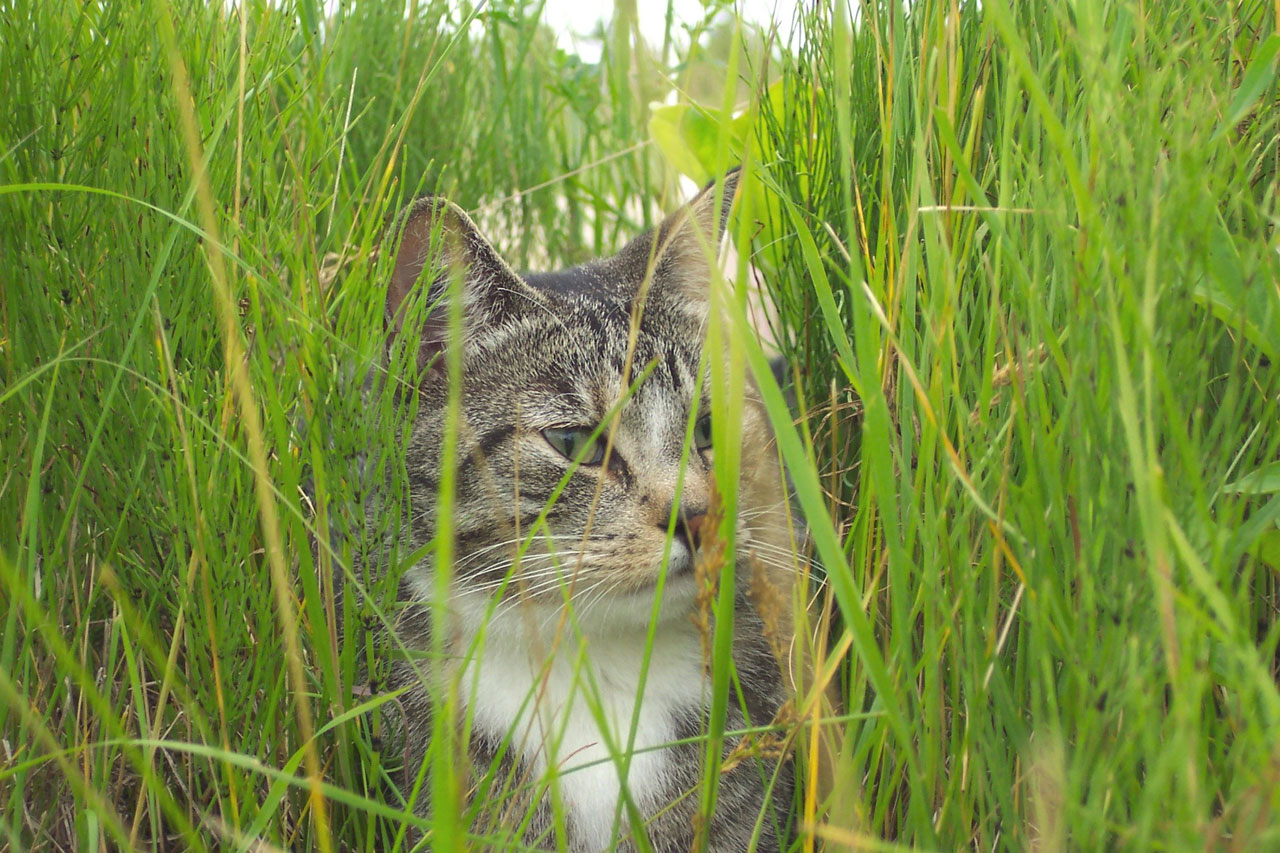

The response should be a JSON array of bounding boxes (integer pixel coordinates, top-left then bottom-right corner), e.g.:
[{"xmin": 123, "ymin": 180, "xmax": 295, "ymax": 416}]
[{"xmin": 366, "ymin": 172, "xmax": 794, "ymax": 853}]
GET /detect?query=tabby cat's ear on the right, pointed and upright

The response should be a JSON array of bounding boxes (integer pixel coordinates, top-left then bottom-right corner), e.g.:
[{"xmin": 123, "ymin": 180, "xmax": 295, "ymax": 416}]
[{"xmin": 618, "ymin": 168, "xmax": 741, "ymax": 313}]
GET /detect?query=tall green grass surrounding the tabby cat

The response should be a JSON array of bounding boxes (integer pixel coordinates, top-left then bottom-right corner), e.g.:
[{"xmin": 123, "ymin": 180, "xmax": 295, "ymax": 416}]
[{"xmin": 0, "ymin": 0, "xmax": 1280, "ymax": 850}]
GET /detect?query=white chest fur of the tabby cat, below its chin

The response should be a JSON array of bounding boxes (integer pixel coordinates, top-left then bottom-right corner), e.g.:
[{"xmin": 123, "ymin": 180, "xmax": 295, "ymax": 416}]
[{"xmin": 462, "ymin": 596, "xmax": 707, "ymax": 850}]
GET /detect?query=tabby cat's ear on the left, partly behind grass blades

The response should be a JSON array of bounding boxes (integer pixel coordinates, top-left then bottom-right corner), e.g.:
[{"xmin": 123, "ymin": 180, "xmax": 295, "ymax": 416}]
[{"xmin": 384, "ymin": 196, "xmax": 538, "ymax": 368}]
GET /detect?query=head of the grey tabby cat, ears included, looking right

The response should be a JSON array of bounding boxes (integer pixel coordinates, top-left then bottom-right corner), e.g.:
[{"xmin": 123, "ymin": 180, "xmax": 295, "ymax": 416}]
[{"xmin": 387, "ymin": 174, "xmax": 782, "ymax": 620}]
